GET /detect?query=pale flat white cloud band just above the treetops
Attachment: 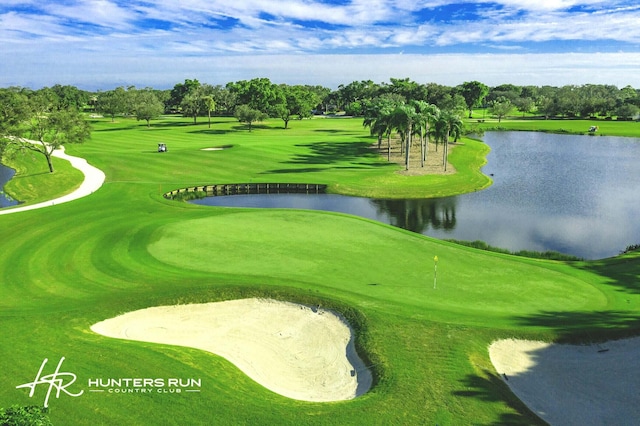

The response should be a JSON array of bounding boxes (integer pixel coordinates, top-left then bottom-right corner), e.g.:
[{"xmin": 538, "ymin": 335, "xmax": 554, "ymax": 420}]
[{"xmin": 0, "ymin": 50, "xmax": 640, "ymax": 90}]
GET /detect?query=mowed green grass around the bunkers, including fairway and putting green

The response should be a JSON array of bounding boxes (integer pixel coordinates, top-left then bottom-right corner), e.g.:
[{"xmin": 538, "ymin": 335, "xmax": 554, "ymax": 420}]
[{"xmin": 0, "ymin": 115, "xmax": 640, "ymax": 425}]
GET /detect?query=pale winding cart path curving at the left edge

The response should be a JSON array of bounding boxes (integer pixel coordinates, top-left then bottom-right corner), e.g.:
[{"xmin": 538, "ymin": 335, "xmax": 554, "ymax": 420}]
[{"xmin": 0, "ymin": 147, "xmax": 105, "ymax": 215}]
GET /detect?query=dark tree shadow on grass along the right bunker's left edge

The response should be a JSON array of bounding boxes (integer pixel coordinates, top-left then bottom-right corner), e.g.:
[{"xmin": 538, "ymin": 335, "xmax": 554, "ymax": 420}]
[{"xmin": 452, "ymin": 370, "xmax": 547, "ymax": 425}]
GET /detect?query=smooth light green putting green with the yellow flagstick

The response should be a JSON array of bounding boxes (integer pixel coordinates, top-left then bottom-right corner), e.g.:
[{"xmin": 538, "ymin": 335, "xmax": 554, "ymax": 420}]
[{"xmin": 148, "ymin": 209, "xmax": 607, "ymax": 323}]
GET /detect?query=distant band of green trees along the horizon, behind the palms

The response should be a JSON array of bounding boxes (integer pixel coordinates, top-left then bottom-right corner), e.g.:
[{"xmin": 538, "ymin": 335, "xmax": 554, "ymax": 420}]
[{"xmin": 0, "ymin": 78, "xmax": 640, "ymax": 122}]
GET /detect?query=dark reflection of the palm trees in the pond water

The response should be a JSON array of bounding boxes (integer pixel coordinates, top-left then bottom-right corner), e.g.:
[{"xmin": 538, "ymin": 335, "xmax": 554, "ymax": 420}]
[{"xmin": 371, "ymin": 197, "xmax": 457, "ymax": 234}]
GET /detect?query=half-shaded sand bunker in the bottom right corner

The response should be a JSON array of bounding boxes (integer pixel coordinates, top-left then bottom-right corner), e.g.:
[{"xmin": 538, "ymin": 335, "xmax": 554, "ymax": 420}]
[{"xmin": 489, "ymin": 338, "xmax": 640, "ymax": 426}]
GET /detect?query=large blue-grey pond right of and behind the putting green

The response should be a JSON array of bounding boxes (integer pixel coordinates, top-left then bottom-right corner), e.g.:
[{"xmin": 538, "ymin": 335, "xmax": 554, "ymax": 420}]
[{"xmin": 193, "ymin": 132, "xmax": 640, "ymax": 259}]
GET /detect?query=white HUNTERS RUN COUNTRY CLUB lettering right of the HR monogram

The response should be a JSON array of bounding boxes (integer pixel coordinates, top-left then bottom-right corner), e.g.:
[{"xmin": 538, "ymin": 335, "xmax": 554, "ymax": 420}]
[{"xmin": 87, "ymin": 378, "xmax": 202, "ymax": 393}]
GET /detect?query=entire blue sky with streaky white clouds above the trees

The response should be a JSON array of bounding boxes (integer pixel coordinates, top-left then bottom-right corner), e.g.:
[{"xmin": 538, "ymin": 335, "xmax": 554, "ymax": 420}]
[{"xmin": 0, "ymin": 0, "xmax": 640, "ymax": 90}]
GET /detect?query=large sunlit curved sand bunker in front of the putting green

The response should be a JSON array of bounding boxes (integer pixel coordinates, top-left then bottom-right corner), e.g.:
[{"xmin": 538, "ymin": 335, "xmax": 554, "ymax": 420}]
[{"xmin": 91, "ymin": 299, "xmax": 371, "ymax": 402}]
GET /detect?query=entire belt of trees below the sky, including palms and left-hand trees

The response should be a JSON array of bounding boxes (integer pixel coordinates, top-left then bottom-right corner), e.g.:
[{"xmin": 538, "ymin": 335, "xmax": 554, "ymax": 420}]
[{"xmin": 0, "ymin": 78, "xmax": 640, "ymax": 171}]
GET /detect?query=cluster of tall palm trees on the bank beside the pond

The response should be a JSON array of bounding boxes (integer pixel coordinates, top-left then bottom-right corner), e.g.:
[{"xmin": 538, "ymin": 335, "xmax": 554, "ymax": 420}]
[{"xmin": 362, "ymin": 97, "xmax": 463, "ymax": 171}]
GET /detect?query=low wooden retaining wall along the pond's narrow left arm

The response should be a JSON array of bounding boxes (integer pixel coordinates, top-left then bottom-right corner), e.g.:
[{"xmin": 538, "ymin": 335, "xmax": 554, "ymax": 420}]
[{"xmin": 164, "ymin": 183, "xmax": 327, "ymax": 199}]
